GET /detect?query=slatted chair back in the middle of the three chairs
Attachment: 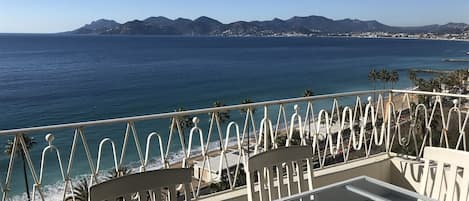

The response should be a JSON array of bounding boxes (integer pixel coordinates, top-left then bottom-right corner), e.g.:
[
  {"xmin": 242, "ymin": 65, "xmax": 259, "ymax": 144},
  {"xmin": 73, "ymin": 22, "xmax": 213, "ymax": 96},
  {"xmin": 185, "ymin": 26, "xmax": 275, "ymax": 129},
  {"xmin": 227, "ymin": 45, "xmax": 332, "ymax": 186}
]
[{"xmin": 246, "ymin": 146, "xmax": 313, "ymax": 201}]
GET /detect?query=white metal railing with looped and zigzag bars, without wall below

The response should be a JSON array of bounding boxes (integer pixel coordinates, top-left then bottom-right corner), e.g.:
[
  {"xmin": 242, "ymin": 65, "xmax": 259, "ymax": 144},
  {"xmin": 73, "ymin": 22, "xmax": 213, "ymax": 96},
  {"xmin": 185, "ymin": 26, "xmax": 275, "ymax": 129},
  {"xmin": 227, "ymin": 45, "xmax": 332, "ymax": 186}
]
[{"xmin": 0, "ymin": 90, "xmax": 469, "ymax": 201}]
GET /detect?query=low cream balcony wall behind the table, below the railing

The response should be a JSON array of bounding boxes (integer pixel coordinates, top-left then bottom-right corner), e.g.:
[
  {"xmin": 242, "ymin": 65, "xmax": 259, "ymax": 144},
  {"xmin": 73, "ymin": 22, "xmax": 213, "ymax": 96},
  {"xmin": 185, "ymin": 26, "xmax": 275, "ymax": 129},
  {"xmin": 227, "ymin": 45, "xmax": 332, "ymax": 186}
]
[{"xmin": 201, "ymin": 153, "xmax": 468, "ymax": 201}]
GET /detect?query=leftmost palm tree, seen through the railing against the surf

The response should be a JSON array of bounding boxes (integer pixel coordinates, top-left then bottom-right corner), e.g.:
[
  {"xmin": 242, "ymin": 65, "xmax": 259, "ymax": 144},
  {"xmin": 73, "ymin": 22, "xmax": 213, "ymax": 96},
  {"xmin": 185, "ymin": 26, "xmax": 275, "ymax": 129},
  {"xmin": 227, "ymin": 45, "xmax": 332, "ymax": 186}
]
[{"xmin": 4, "ymin": 135, "xmax": 36, "ymax": 200}]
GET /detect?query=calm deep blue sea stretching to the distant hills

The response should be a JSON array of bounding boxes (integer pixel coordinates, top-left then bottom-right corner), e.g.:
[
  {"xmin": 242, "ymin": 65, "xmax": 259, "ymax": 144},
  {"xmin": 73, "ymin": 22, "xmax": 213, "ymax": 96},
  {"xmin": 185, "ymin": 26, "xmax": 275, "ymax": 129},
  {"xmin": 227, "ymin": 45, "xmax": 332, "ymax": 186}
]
[{"xmin": 0, "ymin": 34, "xmax": 469, "ymax": 200}]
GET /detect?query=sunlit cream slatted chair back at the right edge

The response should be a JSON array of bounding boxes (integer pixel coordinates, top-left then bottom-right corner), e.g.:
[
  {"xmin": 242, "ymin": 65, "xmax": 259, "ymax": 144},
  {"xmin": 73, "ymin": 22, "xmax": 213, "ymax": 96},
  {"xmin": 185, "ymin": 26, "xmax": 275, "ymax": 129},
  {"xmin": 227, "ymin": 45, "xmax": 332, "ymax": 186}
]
[{"xmin": 419, "ymin": 147, "xmax": 469, "ymax": 201}]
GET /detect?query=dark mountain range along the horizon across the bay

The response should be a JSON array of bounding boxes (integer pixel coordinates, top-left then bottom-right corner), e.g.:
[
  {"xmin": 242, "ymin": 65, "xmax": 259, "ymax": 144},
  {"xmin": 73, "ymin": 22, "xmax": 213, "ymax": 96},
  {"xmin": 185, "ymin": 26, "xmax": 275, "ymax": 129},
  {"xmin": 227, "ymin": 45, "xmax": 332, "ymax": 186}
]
[{"xmin": 67, "ymin": 15, "xmax": 469, "ymax": 36}]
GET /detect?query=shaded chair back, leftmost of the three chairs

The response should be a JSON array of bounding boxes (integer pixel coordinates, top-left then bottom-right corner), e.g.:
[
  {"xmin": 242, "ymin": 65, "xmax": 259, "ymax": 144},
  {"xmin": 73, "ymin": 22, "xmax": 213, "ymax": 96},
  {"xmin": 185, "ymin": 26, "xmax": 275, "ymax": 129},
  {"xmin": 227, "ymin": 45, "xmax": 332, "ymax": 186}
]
[{"xmin": 90, "ymin": 168, "xmax": 192, "ymax": 201}]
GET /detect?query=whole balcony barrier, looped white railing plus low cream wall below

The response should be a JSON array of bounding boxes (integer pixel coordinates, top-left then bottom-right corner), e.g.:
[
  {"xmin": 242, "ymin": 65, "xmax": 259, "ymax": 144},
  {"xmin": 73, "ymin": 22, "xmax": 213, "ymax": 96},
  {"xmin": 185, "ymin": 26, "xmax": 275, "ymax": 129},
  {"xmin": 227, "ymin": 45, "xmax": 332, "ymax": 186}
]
[{"xmin": 0, "ymin": 90, "xmax": 469, "ymax": 200}]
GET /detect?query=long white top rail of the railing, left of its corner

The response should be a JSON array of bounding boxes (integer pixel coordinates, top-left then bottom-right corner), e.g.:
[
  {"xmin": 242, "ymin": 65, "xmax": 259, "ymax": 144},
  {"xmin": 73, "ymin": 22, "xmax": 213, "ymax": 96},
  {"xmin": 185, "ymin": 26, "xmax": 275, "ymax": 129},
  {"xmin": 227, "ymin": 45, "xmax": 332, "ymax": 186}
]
[{"xmin": 0, "ymin": 89, "xmax": 388, "ymax": 135}]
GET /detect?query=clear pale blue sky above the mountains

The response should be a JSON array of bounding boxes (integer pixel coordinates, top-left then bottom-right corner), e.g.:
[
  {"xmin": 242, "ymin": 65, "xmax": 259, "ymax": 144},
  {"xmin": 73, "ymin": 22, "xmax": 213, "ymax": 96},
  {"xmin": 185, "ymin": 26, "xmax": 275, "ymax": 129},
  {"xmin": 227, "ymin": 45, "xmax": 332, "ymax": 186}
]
[{"xmin": 0, "ymin": 0, "xmax": 469, "ymax": 33}]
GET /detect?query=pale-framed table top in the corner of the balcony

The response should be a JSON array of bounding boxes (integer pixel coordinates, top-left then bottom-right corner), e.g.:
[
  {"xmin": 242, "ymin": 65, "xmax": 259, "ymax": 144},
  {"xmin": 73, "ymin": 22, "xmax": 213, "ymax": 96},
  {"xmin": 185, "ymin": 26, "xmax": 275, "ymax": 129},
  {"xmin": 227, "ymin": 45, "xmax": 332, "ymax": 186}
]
[{"xmin": 280, "ymin": 176, "xmax": 433, "ymax": 201}]
